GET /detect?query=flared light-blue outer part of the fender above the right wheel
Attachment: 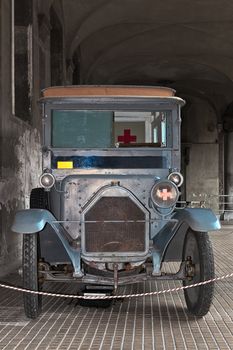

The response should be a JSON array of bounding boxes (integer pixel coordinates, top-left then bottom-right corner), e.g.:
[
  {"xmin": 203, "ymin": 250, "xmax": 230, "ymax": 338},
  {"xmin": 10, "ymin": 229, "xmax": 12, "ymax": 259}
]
[{"xmin": 173, "ymin": 208, "xmax": 221, "ymax": 232}]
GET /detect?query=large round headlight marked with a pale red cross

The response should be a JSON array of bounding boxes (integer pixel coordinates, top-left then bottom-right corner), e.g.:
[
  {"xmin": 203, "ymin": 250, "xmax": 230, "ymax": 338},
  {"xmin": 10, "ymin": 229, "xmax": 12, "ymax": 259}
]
[{"xmin": 151, "ymin": 180, "xmax": 179, "ymax": 209}]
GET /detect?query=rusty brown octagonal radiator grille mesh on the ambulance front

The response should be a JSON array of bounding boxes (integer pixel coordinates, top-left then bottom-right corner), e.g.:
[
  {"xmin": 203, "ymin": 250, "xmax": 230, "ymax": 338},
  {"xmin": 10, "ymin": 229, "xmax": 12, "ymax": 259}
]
[{"xmin": 85, "ymin": 197, "xmax": 145, "ymax": 253}]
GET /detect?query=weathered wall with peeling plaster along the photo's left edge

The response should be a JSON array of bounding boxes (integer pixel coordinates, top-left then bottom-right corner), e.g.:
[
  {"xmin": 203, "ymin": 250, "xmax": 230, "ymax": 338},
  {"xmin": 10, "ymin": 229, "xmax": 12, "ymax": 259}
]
[{"xmin": 0, "ymin": 0, "xmax": 63, "ymax": 275}]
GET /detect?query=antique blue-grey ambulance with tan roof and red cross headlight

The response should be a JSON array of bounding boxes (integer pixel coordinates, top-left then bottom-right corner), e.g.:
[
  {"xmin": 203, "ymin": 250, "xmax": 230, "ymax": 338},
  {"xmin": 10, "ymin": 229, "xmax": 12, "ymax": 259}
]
[{"xmin": 12, "ymin": 86, "xmax": 220, "ymax": 318}]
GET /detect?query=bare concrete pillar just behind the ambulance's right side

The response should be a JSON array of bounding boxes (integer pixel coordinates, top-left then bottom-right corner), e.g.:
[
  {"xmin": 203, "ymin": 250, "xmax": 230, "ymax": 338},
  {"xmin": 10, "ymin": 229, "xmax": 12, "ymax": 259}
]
[{"xmin": 182, "ymin": 97, "xmax": 219, "ymax": 213}]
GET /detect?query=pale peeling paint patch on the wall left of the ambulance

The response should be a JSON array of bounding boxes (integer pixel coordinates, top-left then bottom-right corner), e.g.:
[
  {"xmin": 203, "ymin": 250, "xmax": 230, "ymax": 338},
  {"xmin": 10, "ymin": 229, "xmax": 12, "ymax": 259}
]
[{"xmin": 0, "ymin": 128, "xmax": 42, "ymax": 274}]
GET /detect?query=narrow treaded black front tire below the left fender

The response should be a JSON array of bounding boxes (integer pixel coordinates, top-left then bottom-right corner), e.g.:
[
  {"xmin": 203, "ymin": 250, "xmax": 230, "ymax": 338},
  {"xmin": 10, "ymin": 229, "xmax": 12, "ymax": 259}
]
[{"xmin": 23, "ymin": 233, "xmax": 42, "ymax": 319}]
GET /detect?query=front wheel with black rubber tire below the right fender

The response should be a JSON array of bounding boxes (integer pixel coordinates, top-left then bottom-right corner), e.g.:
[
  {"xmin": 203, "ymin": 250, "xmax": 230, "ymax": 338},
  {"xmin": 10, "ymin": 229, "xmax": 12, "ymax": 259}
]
[{"xmin": 183, "ymin": 229, "xmax": 215, "ymax": 317}]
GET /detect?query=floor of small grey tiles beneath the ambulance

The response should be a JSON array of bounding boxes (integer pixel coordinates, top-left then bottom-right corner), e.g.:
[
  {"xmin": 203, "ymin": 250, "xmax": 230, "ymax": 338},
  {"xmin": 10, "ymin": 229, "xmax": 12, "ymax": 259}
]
[{"xmin": 0, "ymin": 226, "xmax": 233, "ymax": 350}]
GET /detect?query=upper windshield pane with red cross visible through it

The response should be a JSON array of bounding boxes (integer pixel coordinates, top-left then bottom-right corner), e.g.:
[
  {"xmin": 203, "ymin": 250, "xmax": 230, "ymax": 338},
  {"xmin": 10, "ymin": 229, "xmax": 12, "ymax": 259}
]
[{"xmin": 51, "ymin": 110, "xmax": 172, "ymax": 149}]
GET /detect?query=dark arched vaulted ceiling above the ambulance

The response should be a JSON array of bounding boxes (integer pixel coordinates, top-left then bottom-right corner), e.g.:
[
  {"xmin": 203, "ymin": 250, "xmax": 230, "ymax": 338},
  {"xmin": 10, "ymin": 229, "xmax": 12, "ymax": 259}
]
[{"xmin": 57, "ymin": 0, "xmax": 233, "ymax": 117}]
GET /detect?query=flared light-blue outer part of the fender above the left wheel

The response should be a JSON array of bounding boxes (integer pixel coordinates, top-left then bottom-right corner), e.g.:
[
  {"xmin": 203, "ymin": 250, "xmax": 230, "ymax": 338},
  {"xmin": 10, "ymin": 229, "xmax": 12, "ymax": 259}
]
[{"xmin": 11, "ymin": 209, "xmax": 56, "ymax": 233}]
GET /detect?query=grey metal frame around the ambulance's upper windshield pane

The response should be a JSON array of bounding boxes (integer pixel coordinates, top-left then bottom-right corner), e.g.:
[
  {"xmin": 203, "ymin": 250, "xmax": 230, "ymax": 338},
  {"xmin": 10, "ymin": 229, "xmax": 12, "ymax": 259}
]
[{"xmin": 42, "ymin": 97, "xmax": 180, "ymax": 152}]
